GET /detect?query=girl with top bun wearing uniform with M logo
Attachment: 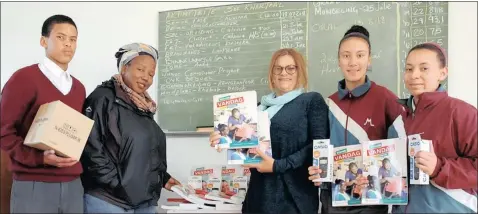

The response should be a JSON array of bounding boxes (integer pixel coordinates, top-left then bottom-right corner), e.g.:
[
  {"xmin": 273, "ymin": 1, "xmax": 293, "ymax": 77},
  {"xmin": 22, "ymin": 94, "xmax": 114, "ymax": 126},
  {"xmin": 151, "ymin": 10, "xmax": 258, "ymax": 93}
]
[{"xmin": 309, "ymin": 25, "xmax": 405, "ymax": 214}]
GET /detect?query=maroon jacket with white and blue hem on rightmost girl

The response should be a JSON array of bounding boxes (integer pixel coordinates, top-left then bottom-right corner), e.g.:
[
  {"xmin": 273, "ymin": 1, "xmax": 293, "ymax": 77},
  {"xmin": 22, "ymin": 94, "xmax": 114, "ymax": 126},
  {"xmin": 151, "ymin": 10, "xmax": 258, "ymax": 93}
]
[{"xmin": 393, "ymin": 87, "xmax": 478, "ymax": 213}]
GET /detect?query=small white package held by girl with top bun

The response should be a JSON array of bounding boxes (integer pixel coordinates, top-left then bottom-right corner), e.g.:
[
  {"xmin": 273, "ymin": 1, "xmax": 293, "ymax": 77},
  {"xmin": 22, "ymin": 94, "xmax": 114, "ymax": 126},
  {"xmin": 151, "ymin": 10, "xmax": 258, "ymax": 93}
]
[{"xmin": 312, "ymin": 139, "xmax": 334, "ymax": 182}]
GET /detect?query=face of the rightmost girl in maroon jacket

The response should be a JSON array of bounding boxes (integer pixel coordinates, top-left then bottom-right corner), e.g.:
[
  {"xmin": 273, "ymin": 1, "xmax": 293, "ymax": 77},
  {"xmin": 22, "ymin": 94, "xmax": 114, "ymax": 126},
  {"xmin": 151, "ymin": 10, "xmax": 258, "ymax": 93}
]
[{"xmin": 404, "ymin": 49, "xmax": 448, "ymax": 97}]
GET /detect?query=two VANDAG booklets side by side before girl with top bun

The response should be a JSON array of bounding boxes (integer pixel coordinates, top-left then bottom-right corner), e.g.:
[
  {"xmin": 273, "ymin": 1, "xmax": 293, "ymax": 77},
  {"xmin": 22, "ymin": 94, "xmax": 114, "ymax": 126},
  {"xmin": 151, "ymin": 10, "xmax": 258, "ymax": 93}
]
[{"xmin": 332, "ymin": 138, "xmax": 408, "ymax": 207}]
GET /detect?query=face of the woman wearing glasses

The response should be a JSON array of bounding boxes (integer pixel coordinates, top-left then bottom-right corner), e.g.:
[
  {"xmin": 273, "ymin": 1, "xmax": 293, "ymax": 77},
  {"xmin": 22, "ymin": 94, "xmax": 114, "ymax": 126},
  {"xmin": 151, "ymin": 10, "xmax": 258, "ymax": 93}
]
[{"xmin": 272, "ymin": 55, "xmax": 298, "ymax": 96}]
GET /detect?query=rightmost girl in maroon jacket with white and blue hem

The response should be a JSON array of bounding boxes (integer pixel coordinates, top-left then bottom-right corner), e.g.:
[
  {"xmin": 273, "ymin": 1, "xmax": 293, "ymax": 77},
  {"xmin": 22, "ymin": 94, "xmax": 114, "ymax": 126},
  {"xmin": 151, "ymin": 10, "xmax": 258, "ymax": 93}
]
[{"xmin": 393, "ymin": 43, "xmax": 478, "ymax": 213}]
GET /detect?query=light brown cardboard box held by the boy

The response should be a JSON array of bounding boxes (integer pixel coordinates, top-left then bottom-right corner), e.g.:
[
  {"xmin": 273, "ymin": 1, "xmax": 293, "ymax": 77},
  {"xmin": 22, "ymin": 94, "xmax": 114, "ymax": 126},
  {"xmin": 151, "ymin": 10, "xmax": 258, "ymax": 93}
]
[{"xmin": 24, "ymin": 101, "xmax": 94, "ymax": 160}]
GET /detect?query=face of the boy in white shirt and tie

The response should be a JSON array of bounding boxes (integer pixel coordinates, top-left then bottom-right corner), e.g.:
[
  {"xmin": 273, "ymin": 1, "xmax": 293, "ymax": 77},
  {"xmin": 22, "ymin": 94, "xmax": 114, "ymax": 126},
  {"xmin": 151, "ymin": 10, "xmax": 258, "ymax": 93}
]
[{"xmin": 40, "ymin": 23, "xmax": 78, "ymax": 70}]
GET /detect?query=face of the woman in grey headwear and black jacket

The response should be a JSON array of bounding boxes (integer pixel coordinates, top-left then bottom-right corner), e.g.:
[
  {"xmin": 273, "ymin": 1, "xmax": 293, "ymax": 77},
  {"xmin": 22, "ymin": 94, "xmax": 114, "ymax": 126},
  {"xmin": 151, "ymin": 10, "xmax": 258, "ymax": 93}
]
[{"xmin": 121, "ymin": 55, "xmax": 156, "ymax": 94}]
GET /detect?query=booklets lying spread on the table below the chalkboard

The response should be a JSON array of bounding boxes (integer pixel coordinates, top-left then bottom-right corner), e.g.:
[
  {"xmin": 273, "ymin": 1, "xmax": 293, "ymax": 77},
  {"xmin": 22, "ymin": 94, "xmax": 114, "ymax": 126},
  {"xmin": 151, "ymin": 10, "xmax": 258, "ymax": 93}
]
[{"xmin": 161, "ymin": 165, "xmax": 249, "ymax": 211}]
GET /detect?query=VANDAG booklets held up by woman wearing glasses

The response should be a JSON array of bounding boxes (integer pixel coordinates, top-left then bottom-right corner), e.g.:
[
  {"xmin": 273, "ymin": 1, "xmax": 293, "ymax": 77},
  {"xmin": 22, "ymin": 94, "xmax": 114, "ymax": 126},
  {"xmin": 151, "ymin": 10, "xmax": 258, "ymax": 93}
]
[{"xmin": 213, "ymin": 91, "xmax": 272, "ymax": 165}]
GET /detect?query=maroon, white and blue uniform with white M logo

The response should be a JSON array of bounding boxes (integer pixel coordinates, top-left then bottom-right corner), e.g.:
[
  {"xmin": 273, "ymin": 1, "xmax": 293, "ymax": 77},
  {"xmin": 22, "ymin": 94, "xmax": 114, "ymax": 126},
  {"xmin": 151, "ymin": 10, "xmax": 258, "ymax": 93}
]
[{"xmin": 320, "ymin": 77, "xmax": 406, "ymax": 213}]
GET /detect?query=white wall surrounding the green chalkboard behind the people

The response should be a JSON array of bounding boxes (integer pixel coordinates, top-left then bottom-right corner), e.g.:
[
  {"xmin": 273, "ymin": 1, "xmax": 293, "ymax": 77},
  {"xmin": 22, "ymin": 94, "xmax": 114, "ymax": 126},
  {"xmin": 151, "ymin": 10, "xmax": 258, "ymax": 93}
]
[{"xmin": 1, "ymin": 2, "xmax": 477, "ymax": 212}]
